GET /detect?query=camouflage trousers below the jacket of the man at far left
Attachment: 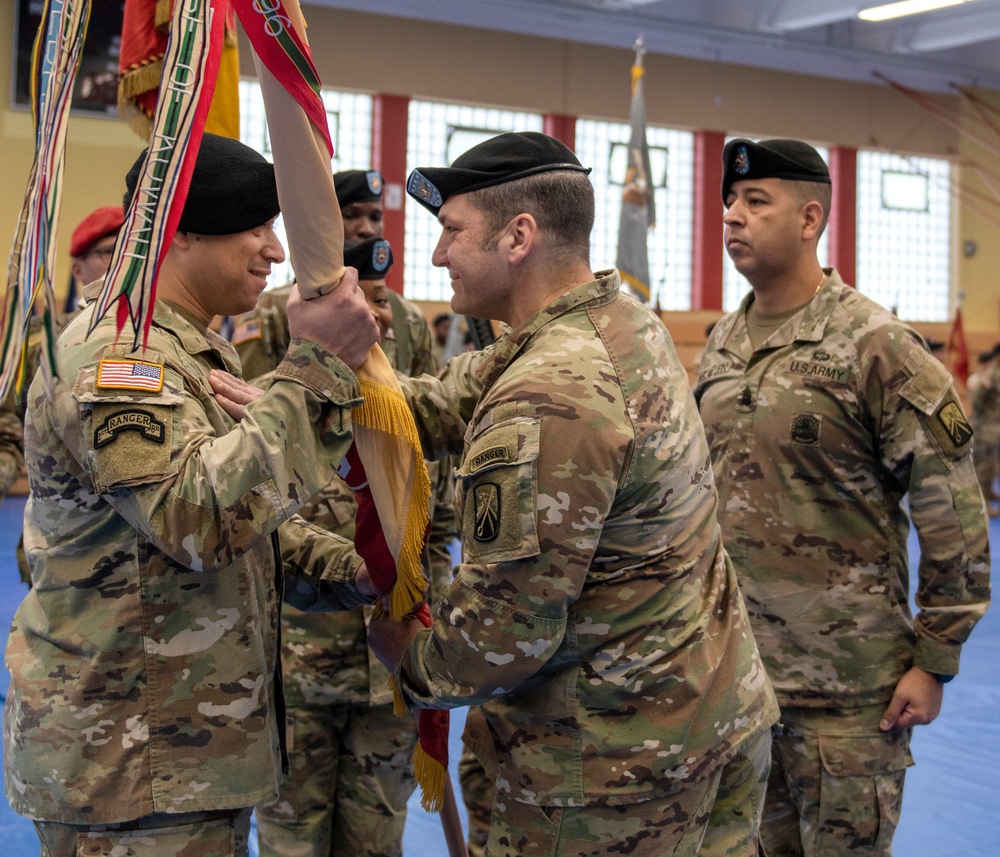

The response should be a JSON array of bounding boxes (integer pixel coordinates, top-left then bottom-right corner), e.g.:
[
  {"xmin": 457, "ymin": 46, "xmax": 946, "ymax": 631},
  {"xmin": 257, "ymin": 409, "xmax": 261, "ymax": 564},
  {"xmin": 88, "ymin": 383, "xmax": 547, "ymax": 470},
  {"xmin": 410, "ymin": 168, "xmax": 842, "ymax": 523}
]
[{"xmin": 35, "ymin": 808, "xmax": 250, "ymax": 857}]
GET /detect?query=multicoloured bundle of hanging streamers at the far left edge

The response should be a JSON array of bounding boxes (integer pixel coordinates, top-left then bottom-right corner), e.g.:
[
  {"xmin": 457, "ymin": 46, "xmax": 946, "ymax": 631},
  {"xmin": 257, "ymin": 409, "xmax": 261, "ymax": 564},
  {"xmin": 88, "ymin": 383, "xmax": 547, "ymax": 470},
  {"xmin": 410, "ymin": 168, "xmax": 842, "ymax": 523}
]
[{"xmin": 0, "ymin": 0, "xmax": 90, "ymax": 398}]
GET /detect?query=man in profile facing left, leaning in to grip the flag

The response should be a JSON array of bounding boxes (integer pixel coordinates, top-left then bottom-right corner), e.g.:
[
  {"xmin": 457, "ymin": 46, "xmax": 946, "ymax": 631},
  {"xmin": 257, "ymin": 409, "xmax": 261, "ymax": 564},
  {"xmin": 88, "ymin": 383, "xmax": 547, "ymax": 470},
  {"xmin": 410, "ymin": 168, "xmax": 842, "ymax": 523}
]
[{"xmin": 369, "ymin": 133, "xmax": 776, "ymax": 857}]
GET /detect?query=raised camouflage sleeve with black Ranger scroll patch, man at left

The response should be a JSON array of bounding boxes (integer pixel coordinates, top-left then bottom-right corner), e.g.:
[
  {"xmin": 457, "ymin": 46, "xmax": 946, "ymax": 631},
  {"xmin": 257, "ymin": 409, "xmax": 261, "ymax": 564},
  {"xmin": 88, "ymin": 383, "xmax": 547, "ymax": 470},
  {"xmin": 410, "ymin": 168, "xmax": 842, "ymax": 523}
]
[{"xmin": 77, "ymin": 340, "xmax": 359, "ymax": 571}]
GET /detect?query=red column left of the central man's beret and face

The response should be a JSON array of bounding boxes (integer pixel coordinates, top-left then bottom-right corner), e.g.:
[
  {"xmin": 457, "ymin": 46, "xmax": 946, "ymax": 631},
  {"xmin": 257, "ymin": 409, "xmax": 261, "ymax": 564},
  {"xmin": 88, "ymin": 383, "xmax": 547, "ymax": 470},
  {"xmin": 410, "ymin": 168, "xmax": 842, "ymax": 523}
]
[{"xmin": 372, "ymin": 95, "xmax": 410, "ymax": 294}]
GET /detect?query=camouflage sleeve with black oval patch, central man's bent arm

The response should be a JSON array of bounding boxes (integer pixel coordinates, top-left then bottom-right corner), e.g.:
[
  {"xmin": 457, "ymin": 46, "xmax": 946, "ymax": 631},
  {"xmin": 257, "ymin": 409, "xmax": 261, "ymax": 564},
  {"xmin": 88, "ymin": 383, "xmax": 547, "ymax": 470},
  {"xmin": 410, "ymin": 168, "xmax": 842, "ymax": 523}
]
[{"xmin": 402, "ymin": 389, "xmax": 625, "ymax": 707}]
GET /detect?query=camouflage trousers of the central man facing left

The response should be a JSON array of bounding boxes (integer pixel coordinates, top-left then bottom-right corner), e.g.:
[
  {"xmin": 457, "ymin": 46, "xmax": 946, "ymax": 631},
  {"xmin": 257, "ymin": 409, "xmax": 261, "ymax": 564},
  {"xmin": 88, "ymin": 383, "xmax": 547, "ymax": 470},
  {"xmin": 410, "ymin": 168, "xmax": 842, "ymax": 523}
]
[{"xmin": 484, "ymin": 732, "xmax": 771, "ymax": 857}]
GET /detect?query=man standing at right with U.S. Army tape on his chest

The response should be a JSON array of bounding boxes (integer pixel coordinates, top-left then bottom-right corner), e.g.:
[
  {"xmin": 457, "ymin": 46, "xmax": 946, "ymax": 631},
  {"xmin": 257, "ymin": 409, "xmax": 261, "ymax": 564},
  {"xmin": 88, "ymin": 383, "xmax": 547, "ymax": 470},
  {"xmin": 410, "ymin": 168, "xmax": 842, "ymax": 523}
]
[{"xmin": 695, "ymin": 139, "xmax": 990, "ymax": 857}]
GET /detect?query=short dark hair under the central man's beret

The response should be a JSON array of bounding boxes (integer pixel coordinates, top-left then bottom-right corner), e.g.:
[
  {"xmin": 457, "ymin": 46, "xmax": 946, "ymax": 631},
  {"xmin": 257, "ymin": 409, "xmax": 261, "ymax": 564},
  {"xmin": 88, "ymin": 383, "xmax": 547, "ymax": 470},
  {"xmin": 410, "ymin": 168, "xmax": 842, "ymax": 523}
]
[{"xmin": 469, "ymin": 170, "xmax": 594, "ymax": 264}]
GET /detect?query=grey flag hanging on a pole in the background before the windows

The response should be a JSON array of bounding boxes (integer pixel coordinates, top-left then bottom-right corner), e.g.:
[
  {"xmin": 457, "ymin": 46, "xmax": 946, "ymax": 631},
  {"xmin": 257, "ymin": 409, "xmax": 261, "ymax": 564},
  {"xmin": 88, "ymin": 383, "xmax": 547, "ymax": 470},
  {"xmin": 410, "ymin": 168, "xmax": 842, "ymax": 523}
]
[{"xmin": 616, "ymin": 37, "xmax": 656, "ymax": 303}]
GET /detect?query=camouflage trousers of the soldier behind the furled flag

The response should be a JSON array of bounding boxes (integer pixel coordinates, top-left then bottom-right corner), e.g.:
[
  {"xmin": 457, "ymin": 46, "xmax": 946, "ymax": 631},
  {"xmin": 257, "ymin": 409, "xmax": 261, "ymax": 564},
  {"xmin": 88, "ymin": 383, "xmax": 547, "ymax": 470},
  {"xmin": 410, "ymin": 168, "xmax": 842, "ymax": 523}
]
[{"xmin": 257, "ymin": 705, "xmax": 417, "ymax": 857}]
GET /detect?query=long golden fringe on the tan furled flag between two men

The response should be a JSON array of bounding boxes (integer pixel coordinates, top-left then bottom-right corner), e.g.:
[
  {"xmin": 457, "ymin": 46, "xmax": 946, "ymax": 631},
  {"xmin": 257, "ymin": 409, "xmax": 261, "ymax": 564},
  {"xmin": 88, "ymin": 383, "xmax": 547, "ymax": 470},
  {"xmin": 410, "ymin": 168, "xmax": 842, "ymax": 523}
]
[{"xmin": 353, "ymin": 378, "xmax": 431, "ymax": 622}]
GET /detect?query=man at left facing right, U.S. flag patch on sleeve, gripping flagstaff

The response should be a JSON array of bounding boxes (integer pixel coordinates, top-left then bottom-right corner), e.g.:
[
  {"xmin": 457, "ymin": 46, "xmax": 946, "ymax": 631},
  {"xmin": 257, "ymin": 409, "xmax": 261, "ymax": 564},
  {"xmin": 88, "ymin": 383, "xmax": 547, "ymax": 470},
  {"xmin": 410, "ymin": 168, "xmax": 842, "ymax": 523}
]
[{"xmin": 4, "ymin": 134, "xmax": 377, "ymax": 857}]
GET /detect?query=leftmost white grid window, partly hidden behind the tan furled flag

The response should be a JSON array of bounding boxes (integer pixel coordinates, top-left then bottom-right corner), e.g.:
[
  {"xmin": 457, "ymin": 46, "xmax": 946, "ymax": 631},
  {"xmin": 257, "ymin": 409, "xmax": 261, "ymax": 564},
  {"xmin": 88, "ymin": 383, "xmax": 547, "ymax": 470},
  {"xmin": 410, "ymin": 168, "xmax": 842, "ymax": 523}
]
[{"xmin": 240, "ymin": 80, "xmax": 372, "ymax": 288}]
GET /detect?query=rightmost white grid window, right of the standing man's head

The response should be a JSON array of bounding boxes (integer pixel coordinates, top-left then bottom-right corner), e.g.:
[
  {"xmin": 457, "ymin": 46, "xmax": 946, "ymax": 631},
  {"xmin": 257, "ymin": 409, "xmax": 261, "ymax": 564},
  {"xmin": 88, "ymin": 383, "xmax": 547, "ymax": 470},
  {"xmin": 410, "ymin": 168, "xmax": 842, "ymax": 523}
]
[{"xmin": 856, "ymin": 151, "xmax": 952, "ymax": 321}]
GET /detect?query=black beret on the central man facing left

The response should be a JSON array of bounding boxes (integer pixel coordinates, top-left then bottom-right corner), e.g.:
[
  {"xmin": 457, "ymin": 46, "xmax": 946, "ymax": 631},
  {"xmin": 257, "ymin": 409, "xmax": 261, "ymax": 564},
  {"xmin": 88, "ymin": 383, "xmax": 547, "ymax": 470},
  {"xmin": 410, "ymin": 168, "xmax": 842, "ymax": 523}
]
[{"xmin": 406, "ymin": 131, "xmax": 590, "ymax": 216}]
